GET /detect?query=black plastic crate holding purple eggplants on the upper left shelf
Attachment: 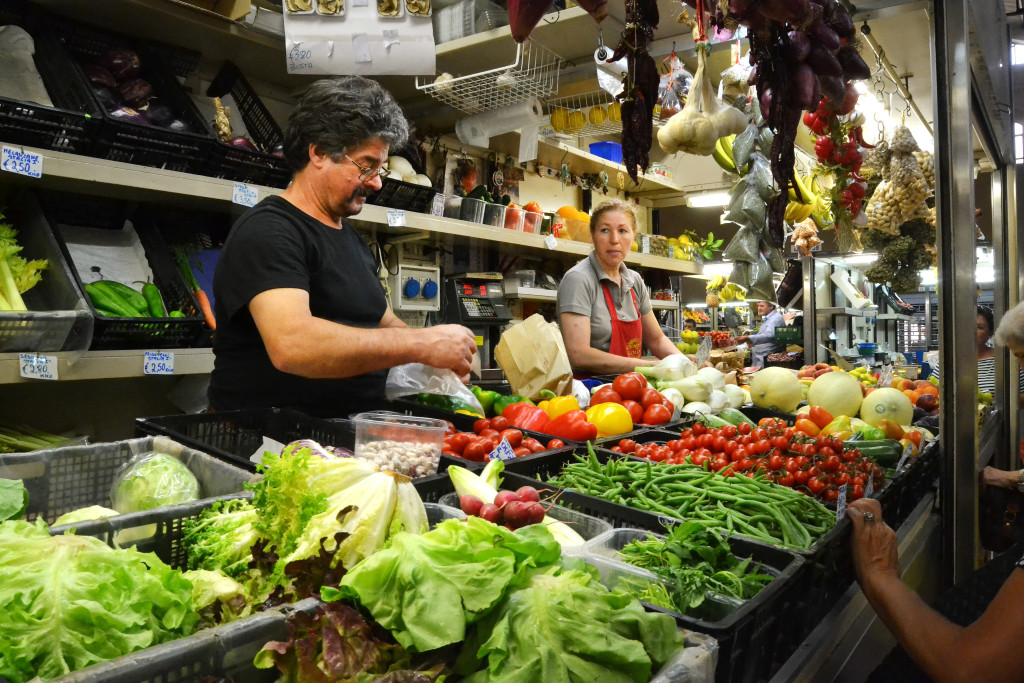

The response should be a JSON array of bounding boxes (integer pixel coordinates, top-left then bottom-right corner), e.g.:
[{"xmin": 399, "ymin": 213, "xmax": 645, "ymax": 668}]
[{"xmin": 54, "ymin": 20, "xmax": 213, "ymax": 174}]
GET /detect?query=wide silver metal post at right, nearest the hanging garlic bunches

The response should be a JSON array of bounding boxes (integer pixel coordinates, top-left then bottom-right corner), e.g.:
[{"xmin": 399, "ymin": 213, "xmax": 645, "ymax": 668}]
[{"xmin": 931, "ymin": 0, "xmax": 978, "ymax": 584}]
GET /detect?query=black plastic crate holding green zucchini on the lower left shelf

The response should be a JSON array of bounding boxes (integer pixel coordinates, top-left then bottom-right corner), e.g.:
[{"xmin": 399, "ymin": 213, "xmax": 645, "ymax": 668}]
[{"xmin": 42, "ymin": 193, "xmax": 209, "ymax": 350}]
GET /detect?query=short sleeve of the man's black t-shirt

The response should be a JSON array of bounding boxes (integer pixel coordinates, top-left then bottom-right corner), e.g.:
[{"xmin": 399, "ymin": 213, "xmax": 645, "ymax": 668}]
[{"xmin": 214, "ymin": 212, "xmax": 315, "ymax": 317}]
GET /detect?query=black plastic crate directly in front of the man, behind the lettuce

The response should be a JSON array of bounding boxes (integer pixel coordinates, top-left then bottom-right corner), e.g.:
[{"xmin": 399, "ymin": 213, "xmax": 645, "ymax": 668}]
[{"xmin": 135, "ymin": 408, "xmax": 467, "ymax": 479}]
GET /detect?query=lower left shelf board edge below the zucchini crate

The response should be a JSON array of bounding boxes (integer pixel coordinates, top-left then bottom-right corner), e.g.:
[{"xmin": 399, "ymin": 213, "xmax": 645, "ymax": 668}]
[{"xmin": 0, "ymin": 348, "xmax": 213, "ymax": 385}]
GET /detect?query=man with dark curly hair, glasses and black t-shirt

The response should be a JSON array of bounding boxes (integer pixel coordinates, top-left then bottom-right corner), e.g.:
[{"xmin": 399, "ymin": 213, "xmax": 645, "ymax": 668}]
[{"xmin": 209, "ymin": 76, "xmax": 476, "ymax": 417}]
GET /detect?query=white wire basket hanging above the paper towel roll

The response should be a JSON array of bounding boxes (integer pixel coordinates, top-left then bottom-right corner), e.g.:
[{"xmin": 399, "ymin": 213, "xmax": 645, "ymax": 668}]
[{"xmin": 416, "ymin": 41, "xmax": 563, "ymax": 114}]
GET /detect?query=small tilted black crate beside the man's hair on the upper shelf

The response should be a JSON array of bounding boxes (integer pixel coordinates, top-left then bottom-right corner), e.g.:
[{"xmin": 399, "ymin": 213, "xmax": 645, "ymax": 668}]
[{"xmin": 206, "ymin": 61, "xmax": 292, "ymax": 187}]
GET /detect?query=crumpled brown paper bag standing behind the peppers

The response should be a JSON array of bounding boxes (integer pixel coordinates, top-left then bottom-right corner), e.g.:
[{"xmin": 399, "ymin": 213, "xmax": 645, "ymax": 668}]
[{"xmin": 495, "ymin": 313, "xmax": 572, "ymax": 399}]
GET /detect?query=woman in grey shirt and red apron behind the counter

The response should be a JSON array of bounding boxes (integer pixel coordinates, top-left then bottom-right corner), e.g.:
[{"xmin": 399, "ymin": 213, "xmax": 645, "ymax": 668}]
[{"xmin": 558, "ymin": 200, "xmax": 679, "ymax": 376}]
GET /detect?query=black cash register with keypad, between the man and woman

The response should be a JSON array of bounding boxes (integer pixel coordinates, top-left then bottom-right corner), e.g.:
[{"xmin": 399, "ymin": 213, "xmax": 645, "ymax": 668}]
[{"xmin": 444, "ymin": 272, "xmax": 512, "ymax": 368}]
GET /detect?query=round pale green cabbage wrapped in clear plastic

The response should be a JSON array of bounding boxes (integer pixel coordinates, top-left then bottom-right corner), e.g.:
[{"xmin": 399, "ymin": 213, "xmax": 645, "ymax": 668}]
[{"xmin": 111, "ymin": 451, "xmax": 201, "ymax": 514}]
